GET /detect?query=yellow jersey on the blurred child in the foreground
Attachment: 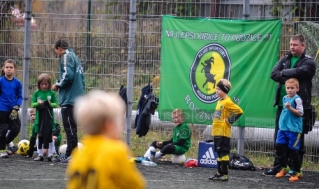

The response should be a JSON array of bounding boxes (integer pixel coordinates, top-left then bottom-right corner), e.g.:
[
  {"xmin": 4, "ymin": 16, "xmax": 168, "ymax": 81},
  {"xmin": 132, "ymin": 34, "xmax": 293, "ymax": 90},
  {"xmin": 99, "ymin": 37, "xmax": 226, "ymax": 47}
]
[{"xmin": 66, "ymin": 135, "xmax": 145, "ymax": 189}]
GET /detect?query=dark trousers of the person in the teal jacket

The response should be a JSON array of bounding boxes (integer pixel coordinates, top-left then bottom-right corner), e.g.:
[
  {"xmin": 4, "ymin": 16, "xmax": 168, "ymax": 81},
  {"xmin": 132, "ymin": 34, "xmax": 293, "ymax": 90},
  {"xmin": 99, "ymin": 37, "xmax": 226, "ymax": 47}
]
[{"xmin": 61, "ymin": 105, "xmax": 78, "ymax": 156}]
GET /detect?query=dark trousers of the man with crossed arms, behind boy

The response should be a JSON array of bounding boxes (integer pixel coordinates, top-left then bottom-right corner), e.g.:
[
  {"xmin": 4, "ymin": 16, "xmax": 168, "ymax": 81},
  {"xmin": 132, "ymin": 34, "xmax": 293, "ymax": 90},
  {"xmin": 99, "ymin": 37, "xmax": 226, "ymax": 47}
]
[{"xmin": 274, "ymin": 106, "xmax": 310, "ymax": 170}]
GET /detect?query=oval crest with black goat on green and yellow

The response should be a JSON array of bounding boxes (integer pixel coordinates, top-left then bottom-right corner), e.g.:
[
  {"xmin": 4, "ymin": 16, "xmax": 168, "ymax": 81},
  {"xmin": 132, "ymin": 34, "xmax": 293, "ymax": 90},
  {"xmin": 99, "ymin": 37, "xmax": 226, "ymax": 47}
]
[{"xmin": 190, "ymin": 43, "xmax": 231, "ymax": 103}]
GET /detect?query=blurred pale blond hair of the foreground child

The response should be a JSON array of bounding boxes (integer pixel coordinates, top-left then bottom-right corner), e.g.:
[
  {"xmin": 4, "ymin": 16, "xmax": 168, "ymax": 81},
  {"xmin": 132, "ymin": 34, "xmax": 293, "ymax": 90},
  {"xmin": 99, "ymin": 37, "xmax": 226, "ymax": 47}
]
[{"xmin": 74, "ymin": 90, "xmax": 125, "ymax": 135}]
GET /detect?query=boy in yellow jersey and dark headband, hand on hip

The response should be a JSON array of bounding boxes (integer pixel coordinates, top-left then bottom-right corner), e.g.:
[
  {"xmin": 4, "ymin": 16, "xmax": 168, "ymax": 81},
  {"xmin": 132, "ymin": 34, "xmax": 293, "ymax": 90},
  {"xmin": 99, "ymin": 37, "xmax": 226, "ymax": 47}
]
[{"xmin": 209, "ymin": 79, "xmax": 243, "ymax": 181}]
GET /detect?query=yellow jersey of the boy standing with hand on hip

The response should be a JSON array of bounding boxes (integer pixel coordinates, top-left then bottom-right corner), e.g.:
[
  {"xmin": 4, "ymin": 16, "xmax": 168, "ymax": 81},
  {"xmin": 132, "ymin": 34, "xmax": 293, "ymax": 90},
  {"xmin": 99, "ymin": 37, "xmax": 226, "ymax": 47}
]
[{"xmin": 212, "ymin": 97, "xmax": 243, "ymax": 138}]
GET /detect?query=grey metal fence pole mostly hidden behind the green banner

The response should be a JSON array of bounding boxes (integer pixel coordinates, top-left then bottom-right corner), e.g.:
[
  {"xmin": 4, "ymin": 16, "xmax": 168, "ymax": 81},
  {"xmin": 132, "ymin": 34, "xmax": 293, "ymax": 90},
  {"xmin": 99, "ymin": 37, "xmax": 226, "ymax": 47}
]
[{"xmin": 237, "ymin": 0, "xmax": 250, "ymax": 155}]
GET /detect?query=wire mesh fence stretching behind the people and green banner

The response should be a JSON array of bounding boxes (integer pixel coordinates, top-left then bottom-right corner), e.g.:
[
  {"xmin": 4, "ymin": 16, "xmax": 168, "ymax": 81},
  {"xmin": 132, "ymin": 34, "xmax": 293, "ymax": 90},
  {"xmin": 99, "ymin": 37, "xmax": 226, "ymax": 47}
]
[{"xmin": 0, "ymin": 0, "xmax": 319, "ymax": 166}]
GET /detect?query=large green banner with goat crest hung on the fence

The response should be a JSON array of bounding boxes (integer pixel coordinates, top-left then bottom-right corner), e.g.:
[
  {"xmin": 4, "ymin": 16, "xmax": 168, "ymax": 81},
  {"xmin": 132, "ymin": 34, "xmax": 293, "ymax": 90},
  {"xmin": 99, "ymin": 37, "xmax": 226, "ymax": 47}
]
[{"xmin": 159, "ymin": 16, "xmax": 281, "ymax": 127}]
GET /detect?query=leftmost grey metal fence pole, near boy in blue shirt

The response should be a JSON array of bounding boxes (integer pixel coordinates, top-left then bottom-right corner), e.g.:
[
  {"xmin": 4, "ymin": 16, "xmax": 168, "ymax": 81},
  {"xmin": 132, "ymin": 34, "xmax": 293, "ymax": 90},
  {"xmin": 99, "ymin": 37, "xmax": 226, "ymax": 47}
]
[{"xmin": 20, "ymin": 0, "xmax": 31, "ymax": 139}]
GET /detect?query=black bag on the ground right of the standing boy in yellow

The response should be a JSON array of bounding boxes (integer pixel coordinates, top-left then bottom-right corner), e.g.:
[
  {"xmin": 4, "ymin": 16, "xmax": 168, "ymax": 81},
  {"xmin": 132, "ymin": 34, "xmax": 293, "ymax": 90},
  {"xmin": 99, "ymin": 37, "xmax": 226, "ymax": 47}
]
[{"xmin": 229, "ymin": 154, "xmax": 256, "ymax": 171}]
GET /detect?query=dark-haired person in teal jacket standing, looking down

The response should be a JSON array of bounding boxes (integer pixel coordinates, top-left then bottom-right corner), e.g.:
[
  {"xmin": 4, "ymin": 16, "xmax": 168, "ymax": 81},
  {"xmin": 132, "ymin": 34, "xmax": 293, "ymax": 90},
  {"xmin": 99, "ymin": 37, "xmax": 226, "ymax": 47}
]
[{"xmin": 52, "ymin": 39, "xmax": 85, "ymax": 163}]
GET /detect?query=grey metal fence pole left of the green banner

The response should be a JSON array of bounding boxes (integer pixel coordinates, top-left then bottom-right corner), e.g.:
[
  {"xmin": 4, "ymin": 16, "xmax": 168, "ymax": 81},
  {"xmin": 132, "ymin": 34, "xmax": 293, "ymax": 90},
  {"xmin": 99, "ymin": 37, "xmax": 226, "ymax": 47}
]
[{"xmin": 126, "ymin": 0, "xmax": 136, "ymax": 146}]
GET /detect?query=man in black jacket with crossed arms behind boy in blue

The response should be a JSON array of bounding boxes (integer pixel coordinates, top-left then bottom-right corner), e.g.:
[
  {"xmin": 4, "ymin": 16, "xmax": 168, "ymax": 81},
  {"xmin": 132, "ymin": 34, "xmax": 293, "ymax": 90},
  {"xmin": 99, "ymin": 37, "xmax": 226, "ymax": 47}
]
[{"xmin": 264, "ymin": 34, "xmax": 316, "ymax": 175}]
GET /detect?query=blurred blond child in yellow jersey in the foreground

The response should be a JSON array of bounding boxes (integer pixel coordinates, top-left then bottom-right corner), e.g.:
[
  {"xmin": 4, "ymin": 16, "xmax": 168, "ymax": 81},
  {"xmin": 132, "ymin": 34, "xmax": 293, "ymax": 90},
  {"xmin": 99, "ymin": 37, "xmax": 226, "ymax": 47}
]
[{"xmin": 66, "ymin": 90, "xmax": 145, "ymax": 189}]
